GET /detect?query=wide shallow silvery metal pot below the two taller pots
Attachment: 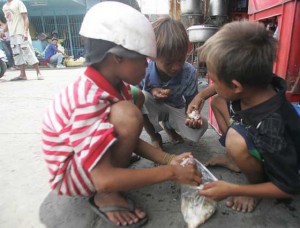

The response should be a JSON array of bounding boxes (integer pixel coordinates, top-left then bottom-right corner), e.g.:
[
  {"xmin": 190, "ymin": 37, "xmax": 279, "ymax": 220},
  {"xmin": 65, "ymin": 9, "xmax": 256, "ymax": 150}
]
[{"xmin": 187, "ymin": 25, "xmax": 219, "ymax": 43}]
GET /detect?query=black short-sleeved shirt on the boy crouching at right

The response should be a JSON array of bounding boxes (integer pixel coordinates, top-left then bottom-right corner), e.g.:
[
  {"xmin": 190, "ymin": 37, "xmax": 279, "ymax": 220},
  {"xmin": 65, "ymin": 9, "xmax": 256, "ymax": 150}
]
[{"xmin": 230, "ymin": 77, "xmax": 300, "ymax": 194}]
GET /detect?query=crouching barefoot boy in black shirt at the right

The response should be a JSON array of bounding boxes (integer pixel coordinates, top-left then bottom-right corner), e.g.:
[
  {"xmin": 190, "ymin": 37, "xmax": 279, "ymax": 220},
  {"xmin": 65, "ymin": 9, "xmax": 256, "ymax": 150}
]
[{"xmin": 200, "ymin": 21, "xmax": 300, "ymax": 212}]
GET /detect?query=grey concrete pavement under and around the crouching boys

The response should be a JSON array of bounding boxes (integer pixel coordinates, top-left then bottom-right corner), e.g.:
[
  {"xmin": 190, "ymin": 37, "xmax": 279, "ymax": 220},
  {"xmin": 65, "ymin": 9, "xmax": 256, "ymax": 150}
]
[{"xmin": 0, "ymin": 68, "xmax": 300, "ymax": 228}]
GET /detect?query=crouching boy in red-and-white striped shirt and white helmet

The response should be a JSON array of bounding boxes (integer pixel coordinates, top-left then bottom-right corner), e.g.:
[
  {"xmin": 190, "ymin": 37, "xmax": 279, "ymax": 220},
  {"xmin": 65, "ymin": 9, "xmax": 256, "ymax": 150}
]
[{"xmin": 43, "ymin": 1, "xmax": 201, "ymax": 227}]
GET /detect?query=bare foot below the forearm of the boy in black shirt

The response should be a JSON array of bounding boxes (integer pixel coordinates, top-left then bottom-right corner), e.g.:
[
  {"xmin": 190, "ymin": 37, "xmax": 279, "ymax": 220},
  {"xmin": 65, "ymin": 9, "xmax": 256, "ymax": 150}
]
[{"xmin": 226, "ymin": 196, "xmax": 259, "ymax": 213}]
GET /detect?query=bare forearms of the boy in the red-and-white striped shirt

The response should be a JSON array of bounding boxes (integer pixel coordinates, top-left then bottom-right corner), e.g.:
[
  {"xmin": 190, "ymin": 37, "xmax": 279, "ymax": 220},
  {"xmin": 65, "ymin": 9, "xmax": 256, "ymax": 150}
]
[{"xmin": 90, "ymin": 140, "xmax": 201, "ymax": 192}]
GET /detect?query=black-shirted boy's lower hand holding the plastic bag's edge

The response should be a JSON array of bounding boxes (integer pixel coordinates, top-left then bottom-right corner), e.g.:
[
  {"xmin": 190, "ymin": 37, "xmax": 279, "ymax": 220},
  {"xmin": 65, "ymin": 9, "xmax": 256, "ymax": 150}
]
[{"xmin": 199, "ymin": 181, "xmax": 234, "ymax": 201}]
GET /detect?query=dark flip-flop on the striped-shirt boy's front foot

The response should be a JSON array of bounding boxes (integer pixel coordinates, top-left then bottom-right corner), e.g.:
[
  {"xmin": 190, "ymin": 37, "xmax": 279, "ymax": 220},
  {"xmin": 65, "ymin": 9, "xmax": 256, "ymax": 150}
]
[{"xmin": 89, "ymin": 196, "xmax": 148, "ymax": 228}]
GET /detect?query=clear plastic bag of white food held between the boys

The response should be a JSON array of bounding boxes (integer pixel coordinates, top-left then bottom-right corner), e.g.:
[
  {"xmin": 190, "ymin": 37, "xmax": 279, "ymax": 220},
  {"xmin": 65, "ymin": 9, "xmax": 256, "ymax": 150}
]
[{"xmin": 181, "ymin": 158, "xmax": 217, "ymax": 228}]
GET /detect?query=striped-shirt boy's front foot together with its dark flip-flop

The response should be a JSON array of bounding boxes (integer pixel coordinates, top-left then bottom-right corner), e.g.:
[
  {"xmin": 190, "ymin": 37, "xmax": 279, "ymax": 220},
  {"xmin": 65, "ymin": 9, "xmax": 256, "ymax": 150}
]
[{"xmin": 89, "ymin": 193, "xmax": 147, "ymax": 227}]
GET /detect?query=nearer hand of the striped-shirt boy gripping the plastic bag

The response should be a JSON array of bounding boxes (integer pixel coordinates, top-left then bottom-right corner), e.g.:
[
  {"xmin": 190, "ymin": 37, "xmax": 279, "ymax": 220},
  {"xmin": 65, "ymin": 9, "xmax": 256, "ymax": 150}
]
[{"xmin": 173, "ymin": 161, "xmax": 202, "ymax": 186}]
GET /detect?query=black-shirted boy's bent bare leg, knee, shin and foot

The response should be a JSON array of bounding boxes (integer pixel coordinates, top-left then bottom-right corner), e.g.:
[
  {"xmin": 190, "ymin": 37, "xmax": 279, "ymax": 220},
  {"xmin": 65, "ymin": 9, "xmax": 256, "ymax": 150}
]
[{"xmin": 226, "ymin": 128, "xmax": 265, "ymax": 212}]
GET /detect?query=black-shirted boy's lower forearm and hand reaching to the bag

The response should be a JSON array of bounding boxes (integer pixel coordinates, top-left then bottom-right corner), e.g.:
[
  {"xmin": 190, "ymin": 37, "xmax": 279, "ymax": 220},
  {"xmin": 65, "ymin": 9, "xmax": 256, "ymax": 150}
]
[{"xmin": 199, "ymin": 181, "xmax": 292, "ymax": 201}]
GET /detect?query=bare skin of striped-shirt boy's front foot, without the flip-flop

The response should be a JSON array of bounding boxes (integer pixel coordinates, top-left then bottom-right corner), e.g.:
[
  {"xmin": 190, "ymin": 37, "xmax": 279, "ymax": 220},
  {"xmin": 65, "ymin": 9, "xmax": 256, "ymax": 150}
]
[{"xmin": 94, "ymin": 193, "xmax": 146, "ymax": 226}]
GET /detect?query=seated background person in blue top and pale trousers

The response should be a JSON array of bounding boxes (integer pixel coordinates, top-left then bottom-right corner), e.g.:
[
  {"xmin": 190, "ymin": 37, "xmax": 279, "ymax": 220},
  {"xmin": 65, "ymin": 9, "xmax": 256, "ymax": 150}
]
[{"xmin": 45, "ymin": 37, "xmax": 65, "ymax": 68}]
